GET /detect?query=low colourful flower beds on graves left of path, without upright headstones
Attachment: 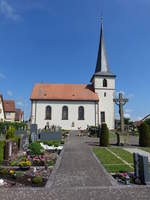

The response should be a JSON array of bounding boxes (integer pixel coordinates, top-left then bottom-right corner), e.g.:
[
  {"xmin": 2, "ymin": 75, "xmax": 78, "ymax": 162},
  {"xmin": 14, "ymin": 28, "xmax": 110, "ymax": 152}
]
[{"xmin": 0, "ymin": 138, "xmax": 63, "ymax": 187}]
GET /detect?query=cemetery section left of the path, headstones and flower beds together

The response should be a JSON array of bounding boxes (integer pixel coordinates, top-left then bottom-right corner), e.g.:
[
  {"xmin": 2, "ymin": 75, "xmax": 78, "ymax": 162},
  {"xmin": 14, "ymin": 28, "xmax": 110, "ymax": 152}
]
[{"xmin": 0, "ymin": 123, "xmax": 66, "ymax": 188}]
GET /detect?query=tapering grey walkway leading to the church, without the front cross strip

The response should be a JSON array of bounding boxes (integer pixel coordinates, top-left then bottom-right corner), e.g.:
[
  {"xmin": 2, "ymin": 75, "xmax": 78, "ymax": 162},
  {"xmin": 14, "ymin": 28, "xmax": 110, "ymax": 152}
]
[{"xmin": 47, "ymin": 132, "xmax": 112, "ymax": 188}]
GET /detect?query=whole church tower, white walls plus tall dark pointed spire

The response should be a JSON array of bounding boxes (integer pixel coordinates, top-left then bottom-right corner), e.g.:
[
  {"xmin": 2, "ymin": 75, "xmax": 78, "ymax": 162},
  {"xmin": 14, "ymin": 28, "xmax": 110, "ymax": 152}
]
[{"xmin": 91, "ymin": 19, "xmax": 116, "ymax": 129}]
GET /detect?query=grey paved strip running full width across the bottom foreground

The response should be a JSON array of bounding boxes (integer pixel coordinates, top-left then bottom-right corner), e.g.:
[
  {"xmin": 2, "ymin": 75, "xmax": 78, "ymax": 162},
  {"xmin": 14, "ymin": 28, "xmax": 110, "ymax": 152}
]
[{"xmin": 0, "ymin": 186, "xmax": 150, "ymax": 200}]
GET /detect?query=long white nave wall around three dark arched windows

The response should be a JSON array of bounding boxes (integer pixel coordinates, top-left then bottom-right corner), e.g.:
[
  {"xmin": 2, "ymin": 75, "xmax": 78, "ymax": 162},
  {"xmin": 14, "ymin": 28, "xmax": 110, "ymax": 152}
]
[{"xmin": 32, "ymin": 101, "xmax": 96, "ymax": 130}]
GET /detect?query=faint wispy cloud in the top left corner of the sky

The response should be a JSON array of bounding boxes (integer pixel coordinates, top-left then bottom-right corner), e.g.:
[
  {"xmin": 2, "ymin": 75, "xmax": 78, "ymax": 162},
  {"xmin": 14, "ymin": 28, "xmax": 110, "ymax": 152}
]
[{"xmin": 0, "ymin": 0, "xmax": 21, "ymax": 21}]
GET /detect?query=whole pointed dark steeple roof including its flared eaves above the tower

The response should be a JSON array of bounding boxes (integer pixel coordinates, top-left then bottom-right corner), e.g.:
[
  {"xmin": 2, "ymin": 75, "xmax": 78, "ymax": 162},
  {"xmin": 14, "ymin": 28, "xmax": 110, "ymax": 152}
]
[{"xmin": 91, "ymin": 17, "xmax": 116, "ymax": 81}]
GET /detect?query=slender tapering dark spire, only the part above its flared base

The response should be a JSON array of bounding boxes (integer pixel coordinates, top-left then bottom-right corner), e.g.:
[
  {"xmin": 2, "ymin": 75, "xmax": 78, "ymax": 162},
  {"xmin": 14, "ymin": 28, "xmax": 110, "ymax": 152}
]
[{"xmin": 95, "ymin": 17, "xmax": 109, "ymax": 73}]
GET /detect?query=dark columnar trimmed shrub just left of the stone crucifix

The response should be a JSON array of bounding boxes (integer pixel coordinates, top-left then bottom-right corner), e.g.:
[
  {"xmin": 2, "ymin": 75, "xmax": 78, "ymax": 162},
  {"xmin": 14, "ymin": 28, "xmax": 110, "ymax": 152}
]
[{"xmin": 100, "ymin": 123, "xmax": 109, "ymax": 147}]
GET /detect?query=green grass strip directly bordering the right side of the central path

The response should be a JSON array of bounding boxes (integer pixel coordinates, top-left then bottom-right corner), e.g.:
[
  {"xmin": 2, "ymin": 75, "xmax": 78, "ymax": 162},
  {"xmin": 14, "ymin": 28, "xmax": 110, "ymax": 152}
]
[{"xmin": 93, "ymin": 147, "xmax": 133, "ymax": 173}]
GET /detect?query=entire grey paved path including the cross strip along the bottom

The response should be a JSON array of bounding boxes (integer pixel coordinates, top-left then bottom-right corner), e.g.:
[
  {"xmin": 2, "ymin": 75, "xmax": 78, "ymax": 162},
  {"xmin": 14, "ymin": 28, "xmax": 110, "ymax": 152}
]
[{"xmin": 0, "ymin": 133, "xmax": 150, "ymax": 200}]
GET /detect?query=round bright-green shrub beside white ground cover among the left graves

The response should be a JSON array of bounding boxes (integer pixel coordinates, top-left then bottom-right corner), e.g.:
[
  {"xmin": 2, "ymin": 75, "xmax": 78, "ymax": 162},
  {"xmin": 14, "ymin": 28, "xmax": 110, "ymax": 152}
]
[{"xmin": 29, "ymin": 142, "xmax": 44, "ymax": 156}]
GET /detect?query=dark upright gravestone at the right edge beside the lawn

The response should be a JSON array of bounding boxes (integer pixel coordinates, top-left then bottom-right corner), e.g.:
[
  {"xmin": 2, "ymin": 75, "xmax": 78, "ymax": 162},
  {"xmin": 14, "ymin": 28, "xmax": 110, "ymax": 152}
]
[{"xmin": 133, "ymin": 153, "xmax": 150, "ymax": 185}]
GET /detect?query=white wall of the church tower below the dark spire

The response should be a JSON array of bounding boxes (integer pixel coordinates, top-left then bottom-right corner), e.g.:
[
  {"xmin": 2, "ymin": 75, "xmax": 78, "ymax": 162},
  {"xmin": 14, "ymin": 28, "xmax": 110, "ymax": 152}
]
[{"xmin": 94, "ymin": 77, "xmax": 115, "ymax": 129}]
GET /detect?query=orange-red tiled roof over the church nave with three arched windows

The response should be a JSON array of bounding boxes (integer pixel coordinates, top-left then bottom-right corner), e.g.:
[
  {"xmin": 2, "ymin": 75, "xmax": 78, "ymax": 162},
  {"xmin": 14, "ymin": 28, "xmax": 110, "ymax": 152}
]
[{"xmin": 30, "ymin": 83, "xmax": 99, "ymax": 101}]
